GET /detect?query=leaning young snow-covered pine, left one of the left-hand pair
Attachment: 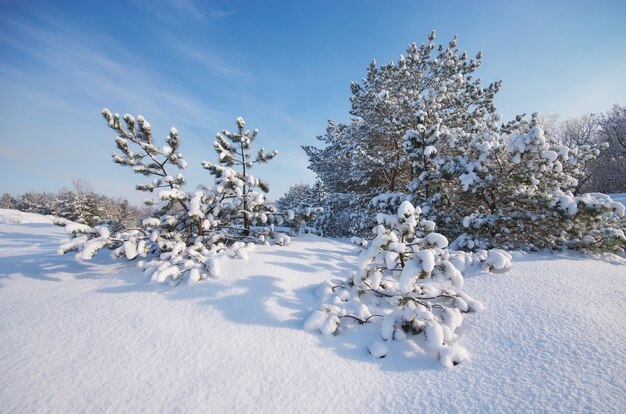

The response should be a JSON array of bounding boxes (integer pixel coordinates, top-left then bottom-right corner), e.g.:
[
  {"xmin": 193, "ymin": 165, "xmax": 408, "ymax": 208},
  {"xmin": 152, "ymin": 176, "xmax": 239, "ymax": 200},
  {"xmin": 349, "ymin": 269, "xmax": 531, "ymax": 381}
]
[{"xmin": 59, "ymin": 109, "xmax": 205, "ymax": 282}]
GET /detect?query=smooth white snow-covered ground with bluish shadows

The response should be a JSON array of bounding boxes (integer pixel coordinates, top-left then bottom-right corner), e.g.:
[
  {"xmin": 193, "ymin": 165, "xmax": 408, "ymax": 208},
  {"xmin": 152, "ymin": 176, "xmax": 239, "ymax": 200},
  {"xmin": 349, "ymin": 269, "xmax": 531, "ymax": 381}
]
[{"xmin": 0, "ymin": 212, "xmax": 626, "ymax": 413}]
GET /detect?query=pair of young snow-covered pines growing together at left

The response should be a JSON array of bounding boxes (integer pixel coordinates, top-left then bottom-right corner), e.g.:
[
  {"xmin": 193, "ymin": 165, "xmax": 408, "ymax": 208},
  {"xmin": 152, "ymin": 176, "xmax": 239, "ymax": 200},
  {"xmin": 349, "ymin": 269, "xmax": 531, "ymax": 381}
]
[{"xmin": 59, "ymin": 109, "xmax": 288, "ymax": 283}]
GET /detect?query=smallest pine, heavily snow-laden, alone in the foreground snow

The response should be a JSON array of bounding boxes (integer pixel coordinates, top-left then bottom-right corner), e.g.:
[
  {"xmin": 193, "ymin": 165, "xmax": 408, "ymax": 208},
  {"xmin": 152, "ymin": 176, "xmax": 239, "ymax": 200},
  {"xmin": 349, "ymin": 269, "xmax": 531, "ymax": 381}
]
[{"xmin": 305, "ymin": 201, "xmax": 511, "ymax": 367}]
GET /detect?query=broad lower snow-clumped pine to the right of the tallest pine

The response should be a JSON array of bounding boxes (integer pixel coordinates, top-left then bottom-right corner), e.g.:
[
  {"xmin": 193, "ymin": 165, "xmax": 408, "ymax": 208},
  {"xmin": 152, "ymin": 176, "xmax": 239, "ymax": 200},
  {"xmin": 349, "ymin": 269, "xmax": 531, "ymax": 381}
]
[{"xmin": 448, "ymin": 114, "xmax": 626, "ymax": 253}]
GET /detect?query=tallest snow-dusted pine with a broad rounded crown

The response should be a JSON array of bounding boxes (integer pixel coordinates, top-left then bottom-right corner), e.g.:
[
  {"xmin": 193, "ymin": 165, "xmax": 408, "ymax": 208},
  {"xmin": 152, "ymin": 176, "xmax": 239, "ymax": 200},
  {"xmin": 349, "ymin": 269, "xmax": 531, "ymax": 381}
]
[{"xmin": 304, "ymin": 32, "xmax": 500, "ymax": 233}]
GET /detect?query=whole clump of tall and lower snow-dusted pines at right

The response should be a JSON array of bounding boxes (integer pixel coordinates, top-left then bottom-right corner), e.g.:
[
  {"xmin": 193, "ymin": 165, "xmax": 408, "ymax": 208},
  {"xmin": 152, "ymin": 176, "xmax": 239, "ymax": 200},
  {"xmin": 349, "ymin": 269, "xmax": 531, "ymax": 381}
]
[{"xmin": 304, "ymin": 33, "xmax": 626, "ymax": 252}]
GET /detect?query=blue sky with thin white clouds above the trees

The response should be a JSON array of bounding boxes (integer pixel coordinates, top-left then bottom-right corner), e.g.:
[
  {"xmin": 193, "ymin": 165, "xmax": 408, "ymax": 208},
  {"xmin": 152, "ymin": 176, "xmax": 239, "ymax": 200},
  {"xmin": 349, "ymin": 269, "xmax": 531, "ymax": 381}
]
[{"xmin": 0, "ymin": 0, "xmax": 626, "ymax": 202}]
